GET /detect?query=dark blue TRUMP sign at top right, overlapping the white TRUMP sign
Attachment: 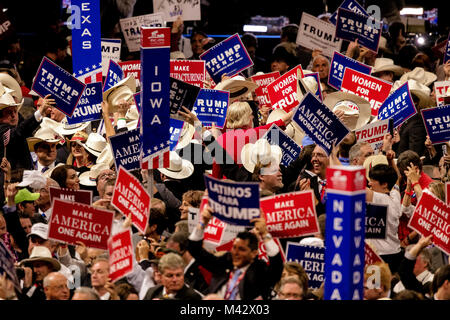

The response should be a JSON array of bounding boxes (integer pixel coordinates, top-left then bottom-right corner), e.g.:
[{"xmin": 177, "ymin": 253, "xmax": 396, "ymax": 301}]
[{"xmin": 336, "ymin": 8, "xmax": 383, "ymax": 52}]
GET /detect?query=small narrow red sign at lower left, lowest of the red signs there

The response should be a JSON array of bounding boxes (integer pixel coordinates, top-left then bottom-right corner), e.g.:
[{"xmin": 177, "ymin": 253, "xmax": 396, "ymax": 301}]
[{"xmin": 108, "ymin": 229, "xmax": 133, "ymax": 282}]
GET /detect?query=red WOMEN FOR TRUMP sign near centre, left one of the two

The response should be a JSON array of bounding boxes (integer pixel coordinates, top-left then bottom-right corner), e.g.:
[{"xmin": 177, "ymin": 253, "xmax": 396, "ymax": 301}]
[{"xmin": 266, "ymin": 65, "xmax": 303, "ymax": 112}]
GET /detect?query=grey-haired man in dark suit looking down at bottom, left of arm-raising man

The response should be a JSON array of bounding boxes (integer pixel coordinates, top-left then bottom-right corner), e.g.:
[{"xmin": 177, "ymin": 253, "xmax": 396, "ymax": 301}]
[{"xmin": 144, "ymin": 253, "xmax": 202, "ymax": 300}]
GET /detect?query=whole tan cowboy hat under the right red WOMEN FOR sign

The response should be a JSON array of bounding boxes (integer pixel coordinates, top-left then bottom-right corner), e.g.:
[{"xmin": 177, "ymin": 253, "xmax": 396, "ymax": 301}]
[{"xmin": 323, "ymin": 91, "xmax": 371, "ymax": 131}]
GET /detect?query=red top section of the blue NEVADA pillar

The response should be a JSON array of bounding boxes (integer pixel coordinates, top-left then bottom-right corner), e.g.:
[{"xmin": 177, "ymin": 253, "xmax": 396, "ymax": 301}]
[{"xmin": 327, "ymin": 166, "xmax": 366, "ymax": 192}]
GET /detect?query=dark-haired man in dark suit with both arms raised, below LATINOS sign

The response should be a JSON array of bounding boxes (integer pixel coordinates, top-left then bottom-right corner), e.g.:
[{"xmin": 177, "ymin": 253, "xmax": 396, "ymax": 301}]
[{"xmin": 188, "ymin": 205, "xmax": 283, "ymax": 300}]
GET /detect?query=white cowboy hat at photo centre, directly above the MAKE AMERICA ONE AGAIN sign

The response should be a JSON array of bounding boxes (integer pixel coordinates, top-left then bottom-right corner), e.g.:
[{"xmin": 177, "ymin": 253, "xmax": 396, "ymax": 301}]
[{"xmin": 241, "ymin": 139, "xmax": 282, "ymax": 173}]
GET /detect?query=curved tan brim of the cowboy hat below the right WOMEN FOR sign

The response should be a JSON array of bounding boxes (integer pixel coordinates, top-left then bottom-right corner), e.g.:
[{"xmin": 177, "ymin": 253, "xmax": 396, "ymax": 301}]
[{"xmin": 323, "ymin": 91, "xmax": 372, "ymax": 131}]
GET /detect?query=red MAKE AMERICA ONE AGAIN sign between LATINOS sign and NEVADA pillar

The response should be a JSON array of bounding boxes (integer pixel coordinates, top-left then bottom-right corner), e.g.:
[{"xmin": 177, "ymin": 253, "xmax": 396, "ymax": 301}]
[{"xmin": 260, "ymin": 190, "xmax": 319, "ymax": 238}]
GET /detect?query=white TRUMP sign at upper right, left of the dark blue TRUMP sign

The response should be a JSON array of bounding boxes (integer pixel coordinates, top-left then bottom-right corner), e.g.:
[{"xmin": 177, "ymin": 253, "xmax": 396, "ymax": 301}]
[{"xmin": 296, "ymin": 12, "xmax": 342, "ymax": 58}]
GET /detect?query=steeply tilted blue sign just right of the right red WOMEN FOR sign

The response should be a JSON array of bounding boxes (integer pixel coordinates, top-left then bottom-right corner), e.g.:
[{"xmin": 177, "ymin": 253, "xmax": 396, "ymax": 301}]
[{"xmin": 378, "ymin": 82, "xmax": 417, "ymax": 128}]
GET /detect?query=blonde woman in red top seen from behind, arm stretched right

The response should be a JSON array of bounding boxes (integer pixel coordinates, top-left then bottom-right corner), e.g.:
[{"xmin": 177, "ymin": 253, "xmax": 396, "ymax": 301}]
[{"xmin": 212, "ymin": 101, "xmax": 294, "ymax": 181}]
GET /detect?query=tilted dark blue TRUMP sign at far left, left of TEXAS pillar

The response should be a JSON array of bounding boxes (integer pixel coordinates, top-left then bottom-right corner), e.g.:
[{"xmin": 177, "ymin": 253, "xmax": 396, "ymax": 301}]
[{"xmin": 31, "ymin": 57, "xmax": 86, "ymax": 117}]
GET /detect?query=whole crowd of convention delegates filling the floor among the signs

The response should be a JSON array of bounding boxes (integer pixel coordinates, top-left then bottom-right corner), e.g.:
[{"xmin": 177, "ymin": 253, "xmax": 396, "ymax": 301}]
[{"xmin": 0, "ymin": 3, "xmax": 450, "ymax": 300}]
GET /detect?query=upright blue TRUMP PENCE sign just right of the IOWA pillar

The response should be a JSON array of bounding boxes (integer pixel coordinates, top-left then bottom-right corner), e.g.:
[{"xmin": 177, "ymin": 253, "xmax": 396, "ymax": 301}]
[{"xmin": 192, "ymin": 89, "xmax": 230, "ymax": 128}]
